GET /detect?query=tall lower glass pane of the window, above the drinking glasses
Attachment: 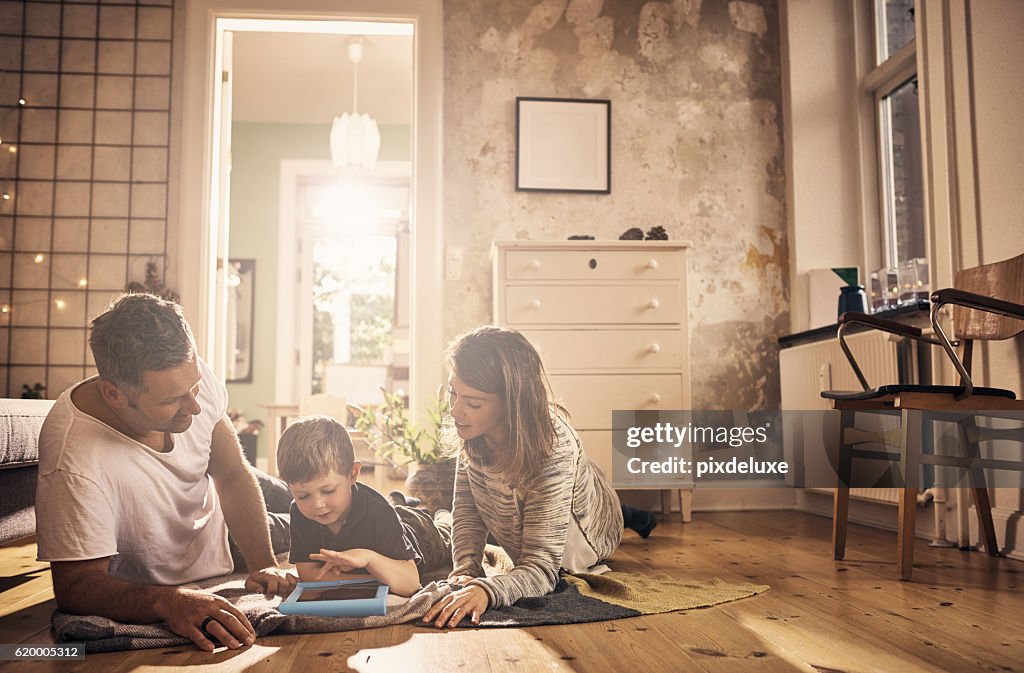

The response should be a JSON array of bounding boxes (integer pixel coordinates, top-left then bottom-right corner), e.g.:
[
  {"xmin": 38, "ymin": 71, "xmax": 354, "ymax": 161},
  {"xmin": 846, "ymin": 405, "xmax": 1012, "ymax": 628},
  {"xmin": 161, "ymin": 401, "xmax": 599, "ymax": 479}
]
[{"xmin": 881, "ymin": 79, "xmax": 925, "ymax": 266}]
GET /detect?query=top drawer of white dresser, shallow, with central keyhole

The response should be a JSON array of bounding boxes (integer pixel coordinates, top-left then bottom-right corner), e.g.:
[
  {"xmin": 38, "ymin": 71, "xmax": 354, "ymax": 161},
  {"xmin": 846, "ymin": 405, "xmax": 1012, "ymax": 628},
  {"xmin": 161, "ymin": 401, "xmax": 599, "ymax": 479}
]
[{"xmin": 505, "ymin": 250, "xmax": 683, "ymax": 281}]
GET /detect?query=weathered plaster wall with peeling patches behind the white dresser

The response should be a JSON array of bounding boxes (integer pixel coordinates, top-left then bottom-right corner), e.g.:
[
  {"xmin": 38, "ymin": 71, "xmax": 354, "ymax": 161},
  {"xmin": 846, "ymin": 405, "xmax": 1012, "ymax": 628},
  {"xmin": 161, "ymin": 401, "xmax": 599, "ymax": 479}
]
[{"xmin": 443, "ymin": 0, "xmax": 788, "ymax": 409}]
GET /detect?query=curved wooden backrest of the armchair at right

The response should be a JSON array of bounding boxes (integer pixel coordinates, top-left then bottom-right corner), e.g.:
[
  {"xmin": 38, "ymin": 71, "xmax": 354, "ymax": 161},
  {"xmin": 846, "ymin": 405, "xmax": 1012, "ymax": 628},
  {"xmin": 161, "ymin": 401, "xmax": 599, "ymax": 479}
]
[{"xmin": 953, "ymin": 254, "xmax": 1024, "ymax": 340}]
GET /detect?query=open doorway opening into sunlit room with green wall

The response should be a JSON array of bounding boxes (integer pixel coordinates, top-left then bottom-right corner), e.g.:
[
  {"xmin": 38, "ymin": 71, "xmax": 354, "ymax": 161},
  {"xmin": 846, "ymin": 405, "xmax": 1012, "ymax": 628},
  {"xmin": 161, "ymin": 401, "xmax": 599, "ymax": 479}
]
[{"xmin": 224, "ymin": 26, "xmax": 414, "ymax": 430}]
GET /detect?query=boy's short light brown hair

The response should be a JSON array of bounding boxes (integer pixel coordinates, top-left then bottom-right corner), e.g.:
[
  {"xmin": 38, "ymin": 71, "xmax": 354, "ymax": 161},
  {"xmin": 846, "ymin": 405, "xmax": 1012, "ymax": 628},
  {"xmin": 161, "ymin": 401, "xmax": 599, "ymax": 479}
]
[{"xmin": 278, "ymin": 416, "xmax": 355, "ymax": 483}]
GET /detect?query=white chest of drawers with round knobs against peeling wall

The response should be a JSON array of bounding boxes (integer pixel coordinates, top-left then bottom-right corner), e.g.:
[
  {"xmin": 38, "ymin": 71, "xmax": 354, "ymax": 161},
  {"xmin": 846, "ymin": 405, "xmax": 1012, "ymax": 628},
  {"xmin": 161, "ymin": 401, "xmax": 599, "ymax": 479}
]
[{"xmin": 492, "ymin": 241, "xmax": 691, "ymax": 520}]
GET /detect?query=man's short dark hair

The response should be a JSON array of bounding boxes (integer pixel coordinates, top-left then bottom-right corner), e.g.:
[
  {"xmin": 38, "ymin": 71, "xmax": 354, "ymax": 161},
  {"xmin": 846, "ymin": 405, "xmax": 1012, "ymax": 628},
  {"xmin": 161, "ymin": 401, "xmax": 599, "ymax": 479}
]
[{"xmin": 89, "ymin": 293, "xmax": 196, "ymax": 392}]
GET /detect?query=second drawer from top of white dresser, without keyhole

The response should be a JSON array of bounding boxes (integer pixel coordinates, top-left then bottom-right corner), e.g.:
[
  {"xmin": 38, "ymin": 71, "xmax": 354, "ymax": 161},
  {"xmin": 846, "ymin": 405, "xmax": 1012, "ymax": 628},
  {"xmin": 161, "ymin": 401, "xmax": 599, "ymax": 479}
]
[{"xmin": 505, "ymin": 285, "xmax": 683, "ymax": 326}]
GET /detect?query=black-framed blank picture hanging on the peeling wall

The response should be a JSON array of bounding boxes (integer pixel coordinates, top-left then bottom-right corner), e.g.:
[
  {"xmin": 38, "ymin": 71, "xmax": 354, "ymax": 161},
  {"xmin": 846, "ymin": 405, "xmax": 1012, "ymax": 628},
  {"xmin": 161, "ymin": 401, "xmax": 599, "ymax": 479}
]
[{"xmin": 515, "ymin": 97, "xmax": 611, "ymax": 194}]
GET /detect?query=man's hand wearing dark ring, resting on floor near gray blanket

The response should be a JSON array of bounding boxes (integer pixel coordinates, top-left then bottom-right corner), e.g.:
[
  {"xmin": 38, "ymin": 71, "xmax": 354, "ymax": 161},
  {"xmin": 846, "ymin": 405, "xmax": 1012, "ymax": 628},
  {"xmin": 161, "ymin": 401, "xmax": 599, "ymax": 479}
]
[{"xmin": 158, "ymin": 589, "xmax": 256, "ymax": 651}]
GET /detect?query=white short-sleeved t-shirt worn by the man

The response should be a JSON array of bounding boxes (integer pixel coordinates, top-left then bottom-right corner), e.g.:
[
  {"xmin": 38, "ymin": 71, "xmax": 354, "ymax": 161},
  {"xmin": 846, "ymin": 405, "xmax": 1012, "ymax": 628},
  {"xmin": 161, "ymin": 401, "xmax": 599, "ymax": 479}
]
[{"xmin": 36, "ymin": 360, "xmax": 233, "ymax": 585}]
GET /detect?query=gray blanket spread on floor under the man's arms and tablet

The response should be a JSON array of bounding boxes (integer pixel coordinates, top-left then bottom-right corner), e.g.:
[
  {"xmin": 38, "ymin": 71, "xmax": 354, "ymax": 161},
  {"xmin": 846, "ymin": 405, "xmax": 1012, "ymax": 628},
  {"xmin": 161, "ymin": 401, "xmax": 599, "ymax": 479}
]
[{"xmin": 52, "ymin": 575, "xmax": 452, "ymax": 653}]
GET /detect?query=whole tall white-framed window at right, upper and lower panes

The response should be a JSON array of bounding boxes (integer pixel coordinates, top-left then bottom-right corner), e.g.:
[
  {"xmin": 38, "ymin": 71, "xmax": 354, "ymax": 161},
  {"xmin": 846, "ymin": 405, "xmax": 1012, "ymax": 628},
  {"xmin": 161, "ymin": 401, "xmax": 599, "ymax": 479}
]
[{"xmin": 864, "ymin": 0, "xmax": 927, "ymax": 272}]
